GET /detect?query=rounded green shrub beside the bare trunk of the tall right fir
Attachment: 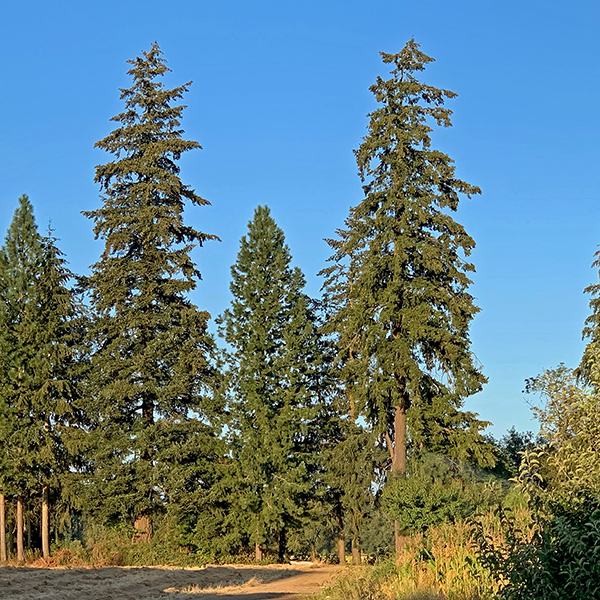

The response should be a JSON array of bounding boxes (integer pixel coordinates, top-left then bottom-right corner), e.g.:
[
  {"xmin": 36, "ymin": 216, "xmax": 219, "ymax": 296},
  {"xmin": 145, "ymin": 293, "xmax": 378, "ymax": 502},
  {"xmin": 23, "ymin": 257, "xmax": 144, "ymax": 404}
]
[{"xmin": 383, "ymin": 454, "xmax": 502, "ymax": 534}]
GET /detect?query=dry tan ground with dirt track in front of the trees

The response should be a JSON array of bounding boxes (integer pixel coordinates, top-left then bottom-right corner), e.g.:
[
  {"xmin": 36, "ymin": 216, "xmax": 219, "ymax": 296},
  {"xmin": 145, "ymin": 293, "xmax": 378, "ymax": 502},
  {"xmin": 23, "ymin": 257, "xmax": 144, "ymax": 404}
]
[{"xmin": 0, "ymin": 563, "xmax": 343, "ymax": 600}]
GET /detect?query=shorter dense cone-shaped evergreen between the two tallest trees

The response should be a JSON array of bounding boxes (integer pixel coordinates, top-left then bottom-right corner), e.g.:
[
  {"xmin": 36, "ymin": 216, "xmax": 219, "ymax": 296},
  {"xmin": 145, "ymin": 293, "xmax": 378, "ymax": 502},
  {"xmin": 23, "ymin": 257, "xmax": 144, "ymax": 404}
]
[{"xmin": 221, "ymin": 206, "xmax": 321, "ymax": 560}]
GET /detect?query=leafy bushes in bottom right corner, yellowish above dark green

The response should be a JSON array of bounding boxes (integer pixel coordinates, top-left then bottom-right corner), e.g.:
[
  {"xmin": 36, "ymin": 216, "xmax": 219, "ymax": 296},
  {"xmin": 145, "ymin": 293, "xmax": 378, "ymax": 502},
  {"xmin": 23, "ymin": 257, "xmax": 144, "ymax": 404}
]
[{"xmin": 478, "ymin": 366, "xmax": 600, "ymax": 600}]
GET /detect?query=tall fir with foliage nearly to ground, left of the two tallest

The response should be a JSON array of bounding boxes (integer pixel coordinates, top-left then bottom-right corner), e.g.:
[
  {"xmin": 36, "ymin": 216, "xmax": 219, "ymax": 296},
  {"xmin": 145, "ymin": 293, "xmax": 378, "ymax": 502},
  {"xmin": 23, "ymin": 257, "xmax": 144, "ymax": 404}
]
[{"xmin": 84, "ymin": 43, "xmax": 217, "ymax": 538}]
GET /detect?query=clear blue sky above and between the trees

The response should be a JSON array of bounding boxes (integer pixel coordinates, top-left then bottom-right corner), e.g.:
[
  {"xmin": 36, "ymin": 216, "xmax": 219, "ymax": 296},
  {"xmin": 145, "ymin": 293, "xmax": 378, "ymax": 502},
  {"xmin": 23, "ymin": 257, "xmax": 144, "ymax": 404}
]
[{"xmin": 0, "ymin": 0, "xmax": 600, "ymax": 435}]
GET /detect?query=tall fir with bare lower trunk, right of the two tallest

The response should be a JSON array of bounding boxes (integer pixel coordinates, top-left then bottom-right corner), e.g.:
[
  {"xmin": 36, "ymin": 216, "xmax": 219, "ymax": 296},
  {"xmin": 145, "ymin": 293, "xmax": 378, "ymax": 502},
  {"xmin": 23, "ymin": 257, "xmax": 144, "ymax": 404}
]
[{"xmin": 324, "ymin": 40, "xmax": 489, "ymax": 543}]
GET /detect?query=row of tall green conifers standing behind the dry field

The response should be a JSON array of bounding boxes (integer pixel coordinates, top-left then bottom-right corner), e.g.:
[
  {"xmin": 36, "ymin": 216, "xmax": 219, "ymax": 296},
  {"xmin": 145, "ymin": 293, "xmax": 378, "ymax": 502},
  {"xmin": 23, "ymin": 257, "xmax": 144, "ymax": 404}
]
[{"xmin": 0, "ymin": 40, "xmax": 524, "ymax": 560}]
